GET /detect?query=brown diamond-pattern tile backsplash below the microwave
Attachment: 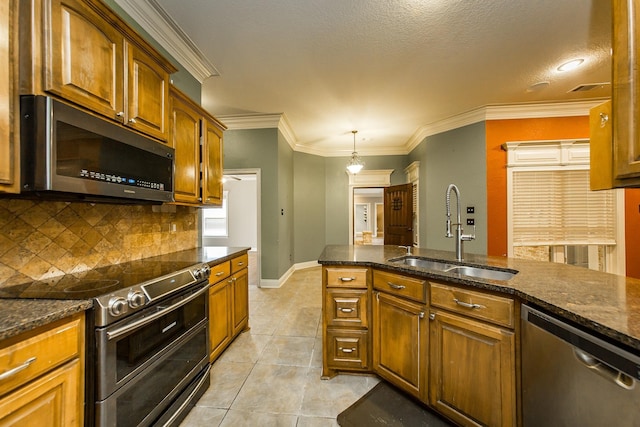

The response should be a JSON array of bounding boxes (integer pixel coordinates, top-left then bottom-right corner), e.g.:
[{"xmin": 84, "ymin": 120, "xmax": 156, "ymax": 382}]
[{"xmin": 0, "ymin": 199, "xmax": 198, "ymax": 286}]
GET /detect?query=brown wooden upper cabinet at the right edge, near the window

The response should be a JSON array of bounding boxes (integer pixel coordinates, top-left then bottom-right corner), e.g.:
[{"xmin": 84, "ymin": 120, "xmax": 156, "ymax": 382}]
[{"xmin": 590, "ymin": 0, "xmax": 640, "ymax": 190}]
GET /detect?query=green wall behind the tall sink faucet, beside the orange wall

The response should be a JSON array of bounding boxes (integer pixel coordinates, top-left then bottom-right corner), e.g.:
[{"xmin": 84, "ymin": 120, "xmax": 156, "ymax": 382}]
[{"xmin": 409, "ymin": 122, "xmax": 487, "ymax": 254}]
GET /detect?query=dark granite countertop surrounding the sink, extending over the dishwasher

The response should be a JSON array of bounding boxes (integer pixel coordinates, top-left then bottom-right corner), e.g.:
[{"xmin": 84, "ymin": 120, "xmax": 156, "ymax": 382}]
[{"xmin": 318, "ymin": 245, "xmax": 640, "ymax": 353}]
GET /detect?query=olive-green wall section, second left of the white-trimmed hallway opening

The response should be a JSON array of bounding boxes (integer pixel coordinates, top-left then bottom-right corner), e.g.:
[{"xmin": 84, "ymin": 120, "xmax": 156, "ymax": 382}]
[{"xmin": 293, "ymin": 152, "xmax": 327, "ymax": 263}]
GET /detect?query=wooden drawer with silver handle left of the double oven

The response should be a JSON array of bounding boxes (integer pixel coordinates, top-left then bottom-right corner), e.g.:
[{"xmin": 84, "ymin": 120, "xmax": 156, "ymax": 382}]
[{"xmin": 0, "ymin": 314, "xmax": 85, "ymax": 395}]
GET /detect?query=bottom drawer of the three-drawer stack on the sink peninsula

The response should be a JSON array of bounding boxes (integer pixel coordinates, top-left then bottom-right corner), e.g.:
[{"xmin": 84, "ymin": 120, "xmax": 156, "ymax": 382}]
[{"xmin": 326, "ymin": 329, "xmax": 369, "ymax": 369}]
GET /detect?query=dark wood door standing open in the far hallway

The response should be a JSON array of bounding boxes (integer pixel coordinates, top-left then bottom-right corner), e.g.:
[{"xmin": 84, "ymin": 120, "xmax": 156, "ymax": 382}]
[{"xmin": 384, "ymin": 184, "xmax": 413, "ymax": 246}]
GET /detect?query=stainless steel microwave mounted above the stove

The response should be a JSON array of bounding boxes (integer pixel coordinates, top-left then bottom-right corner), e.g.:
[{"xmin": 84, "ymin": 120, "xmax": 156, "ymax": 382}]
[{"xmin": 20, "ymin": 95, "xmax": 175, "ymax": 203}]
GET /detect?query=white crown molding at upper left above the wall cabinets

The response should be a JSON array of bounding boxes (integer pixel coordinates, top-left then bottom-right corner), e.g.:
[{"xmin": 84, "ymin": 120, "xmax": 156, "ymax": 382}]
[{"xmin": 114, "ymin": 0, "xmax": 220, "ymax": 83}]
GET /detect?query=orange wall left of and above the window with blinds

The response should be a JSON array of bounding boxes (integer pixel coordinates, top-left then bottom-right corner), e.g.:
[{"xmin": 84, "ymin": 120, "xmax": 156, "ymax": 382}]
[{"xmin": 486, "ymin": 116, "xmax": 589, "ymax": 256}]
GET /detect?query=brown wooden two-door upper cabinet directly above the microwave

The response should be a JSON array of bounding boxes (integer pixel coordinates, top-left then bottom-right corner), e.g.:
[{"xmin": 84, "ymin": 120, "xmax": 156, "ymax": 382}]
[{"xmin": 20, "ymin": 0, "xmax": 177, "ymax": 142}]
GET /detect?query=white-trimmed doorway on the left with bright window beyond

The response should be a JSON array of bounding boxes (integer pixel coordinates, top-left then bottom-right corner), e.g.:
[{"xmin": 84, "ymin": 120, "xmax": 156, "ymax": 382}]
[{"xmin": 200, "ymin": 169, "xmax": 262, "ymax": 286}]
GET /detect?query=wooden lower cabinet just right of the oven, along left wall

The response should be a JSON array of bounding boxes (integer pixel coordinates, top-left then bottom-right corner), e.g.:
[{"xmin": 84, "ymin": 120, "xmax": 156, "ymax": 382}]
[{"xmin": 209, "ymin": 254, "xmax": 249, "ymax": 362}]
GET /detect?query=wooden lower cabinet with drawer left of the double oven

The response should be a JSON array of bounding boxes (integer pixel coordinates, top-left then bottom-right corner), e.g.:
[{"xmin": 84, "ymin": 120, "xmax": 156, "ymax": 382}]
[{"xmin": 0, "ymin": 313, "xmax": 85, "ymax": 426}]
